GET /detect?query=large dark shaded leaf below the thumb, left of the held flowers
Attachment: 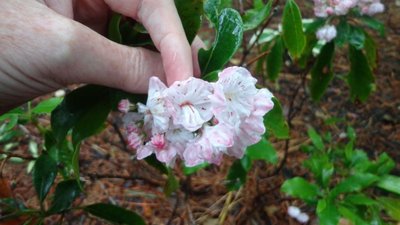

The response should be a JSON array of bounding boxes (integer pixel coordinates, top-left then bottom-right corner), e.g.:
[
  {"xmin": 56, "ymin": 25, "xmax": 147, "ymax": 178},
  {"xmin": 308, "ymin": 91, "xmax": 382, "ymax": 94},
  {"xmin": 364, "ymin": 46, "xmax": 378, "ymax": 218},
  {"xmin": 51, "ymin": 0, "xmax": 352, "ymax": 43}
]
[{"xmin": 51, "ymin": 85, "xmax": 110, "ymax": 142}]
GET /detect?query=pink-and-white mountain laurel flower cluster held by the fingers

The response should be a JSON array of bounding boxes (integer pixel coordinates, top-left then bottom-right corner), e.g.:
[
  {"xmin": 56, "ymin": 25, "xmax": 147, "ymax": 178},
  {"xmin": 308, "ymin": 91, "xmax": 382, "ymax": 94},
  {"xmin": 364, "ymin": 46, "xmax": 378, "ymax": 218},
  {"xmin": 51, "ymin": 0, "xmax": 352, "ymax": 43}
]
[{"xmin": 119, "ymin": 67, "xmax": 274, "ymax": 167}]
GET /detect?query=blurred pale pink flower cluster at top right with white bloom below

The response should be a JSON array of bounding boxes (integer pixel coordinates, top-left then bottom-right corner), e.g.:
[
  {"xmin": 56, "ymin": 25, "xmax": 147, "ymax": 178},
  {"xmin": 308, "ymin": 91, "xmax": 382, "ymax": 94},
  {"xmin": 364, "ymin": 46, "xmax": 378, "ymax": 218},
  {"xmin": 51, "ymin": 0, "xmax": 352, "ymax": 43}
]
[{"xmin": 314, "ymin": 0, "xmax": 385, "ymax": 42}]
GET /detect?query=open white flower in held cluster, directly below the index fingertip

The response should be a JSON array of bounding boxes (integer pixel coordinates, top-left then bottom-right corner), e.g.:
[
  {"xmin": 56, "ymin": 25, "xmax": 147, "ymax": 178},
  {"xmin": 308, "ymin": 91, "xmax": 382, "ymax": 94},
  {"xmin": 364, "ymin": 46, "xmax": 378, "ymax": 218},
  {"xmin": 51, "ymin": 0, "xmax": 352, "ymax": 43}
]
[{"xmin": 167, "ymin": 77, "xmax": 213, "ymax": 132}]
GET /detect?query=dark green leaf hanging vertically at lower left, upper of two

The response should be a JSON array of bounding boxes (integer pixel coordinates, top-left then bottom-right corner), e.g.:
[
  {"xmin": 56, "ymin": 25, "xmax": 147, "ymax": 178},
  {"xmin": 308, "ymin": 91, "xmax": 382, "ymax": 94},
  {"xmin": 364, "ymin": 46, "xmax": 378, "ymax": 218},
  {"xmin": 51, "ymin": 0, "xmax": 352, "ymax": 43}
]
[{"xmin": 33, "ymin": 154, "xmax": 57, "ymax": 202}]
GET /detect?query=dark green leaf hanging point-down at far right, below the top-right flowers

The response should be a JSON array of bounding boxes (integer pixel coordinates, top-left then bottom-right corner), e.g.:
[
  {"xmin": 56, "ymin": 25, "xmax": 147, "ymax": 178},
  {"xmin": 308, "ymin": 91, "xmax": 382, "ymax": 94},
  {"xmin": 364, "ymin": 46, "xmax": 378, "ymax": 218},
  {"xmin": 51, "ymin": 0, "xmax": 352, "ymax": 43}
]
[{"xmin": 347, "ymin": 46, "xmax": 375, "ymax": 102}]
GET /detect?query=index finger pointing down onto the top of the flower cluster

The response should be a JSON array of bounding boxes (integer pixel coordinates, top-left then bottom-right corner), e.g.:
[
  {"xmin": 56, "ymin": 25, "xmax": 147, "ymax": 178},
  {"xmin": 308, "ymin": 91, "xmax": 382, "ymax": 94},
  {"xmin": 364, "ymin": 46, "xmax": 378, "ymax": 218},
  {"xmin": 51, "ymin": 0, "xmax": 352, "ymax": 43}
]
[{"xmin": 105, "ymin": 0, "xmax": 193, "ymax": 85}]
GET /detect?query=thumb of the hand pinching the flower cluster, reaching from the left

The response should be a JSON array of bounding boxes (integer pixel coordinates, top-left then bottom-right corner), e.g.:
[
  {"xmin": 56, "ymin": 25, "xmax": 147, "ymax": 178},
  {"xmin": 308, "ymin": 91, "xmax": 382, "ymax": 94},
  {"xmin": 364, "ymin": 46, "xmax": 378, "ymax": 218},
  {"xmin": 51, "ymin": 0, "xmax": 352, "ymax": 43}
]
[{"xmin": 60, "ymin": 23, "xmax": 165, "ymax": 93}]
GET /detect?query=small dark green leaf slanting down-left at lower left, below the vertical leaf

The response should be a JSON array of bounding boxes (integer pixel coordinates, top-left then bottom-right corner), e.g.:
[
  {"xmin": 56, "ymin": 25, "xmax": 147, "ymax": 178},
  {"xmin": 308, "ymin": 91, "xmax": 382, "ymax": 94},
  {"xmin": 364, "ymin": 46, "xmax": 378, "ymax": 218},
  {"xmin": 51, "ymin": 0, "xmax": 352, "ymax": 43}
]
[{"xmin": 48, "ymin": 180, "xmax": 81, "ymax": 214}]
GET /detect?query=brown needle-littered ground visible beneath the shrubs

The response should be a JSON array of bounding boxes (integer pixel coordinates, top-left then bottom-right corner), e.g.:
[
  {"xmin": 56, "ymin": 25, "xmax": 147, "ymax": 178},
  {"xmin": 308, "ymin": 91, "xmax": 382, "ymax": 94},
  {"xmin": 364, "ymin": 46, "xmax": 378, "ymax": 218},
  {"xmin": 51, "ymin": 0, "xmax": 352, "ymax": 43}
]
[{"xmin": 0, "ymin": 1, "xmax": 400, "ymax": 225}]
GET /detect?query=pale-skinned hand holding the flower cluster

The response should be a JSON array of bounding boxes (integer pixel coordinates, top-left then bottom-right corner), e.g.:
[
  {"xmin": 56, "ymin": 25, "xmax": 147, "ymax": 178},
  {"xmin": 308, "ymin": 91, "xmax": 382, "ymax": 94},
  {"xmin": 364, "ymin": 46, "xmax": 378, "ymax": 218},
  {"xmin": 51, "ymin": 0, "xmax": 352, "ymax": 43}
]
[{"xmin": 0, "ymin": 0, "xmax": 202, "ymax": 114}]
